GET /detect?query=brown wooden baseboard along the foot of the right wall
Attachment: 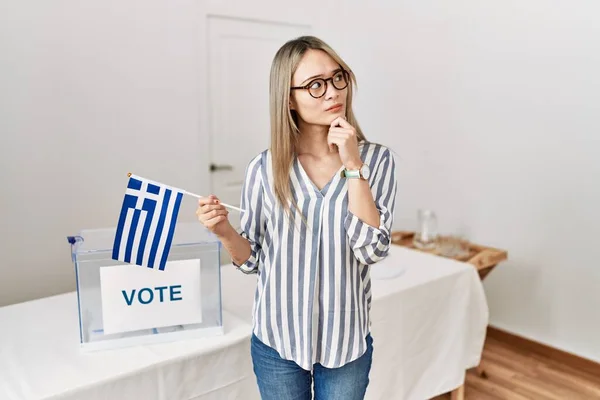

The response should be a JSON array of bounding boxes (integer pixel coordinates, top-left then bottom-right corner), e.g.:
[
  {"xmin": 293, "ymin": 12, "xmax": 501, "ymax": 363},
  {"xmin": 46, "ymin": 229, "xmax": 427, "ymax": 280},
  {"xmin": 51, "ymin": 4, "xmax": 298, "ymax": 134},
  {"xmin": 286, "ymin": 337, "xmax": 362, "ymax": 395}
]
[{"xmin": 487, "ymin": 325, "xmax": 600, "ymax": 376}]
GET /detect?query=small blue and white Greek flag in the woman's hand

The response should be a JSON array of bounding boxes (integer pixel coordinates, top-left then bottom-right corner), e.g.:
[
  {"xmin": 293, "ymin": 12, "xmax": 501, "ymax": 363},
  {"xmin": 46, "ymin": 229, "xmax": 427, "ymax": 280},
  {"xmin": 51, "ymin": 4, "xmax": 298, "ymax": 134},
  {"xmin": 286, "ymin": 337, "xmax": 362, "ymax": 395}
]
[{"xmin": 112, "ymin": 175, "xmax": 184, "ymax": 270}]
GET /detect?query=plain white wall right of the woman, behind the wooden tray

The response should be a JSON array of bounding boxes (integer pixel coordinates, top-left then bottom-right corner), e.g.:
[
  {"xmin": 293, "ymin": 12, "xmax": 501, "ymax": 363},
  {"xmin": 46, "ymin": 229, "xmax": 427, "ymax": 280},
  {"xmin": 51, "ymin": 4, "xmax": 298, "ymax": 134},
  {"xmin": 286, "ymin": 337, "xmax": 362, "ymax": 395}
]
[{"xmin": 314, "ymin": 0, "xmax": 600, "ymax": 361}]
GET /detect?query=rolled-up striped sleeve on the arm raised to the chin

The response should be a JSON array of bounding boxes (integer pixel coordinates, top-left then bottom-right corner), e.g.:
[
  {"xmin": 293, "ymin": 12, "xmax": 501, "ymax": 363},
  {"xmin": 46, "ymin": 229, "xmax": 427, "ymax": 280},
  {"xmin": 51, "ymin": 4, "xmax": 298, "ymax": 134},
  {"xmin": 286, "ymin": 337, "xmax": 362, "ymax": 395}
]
[{"xmin": 344, "ymin": 149, "xmax": 397, "ymax": 264}]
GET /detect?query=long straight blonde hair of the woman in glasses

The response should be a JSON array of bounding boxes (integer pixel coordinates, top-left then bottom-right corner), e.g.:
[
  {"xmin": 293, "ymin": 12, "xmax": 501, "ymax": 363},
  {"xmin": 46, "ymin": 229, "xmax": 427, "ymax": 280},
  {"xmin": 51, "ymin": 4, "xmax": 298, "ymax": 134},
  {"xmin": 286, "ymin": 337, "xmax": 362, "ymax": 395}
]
[{"xmin": 269, "ymin": 36, "xmax": 365, "ymax": 219}]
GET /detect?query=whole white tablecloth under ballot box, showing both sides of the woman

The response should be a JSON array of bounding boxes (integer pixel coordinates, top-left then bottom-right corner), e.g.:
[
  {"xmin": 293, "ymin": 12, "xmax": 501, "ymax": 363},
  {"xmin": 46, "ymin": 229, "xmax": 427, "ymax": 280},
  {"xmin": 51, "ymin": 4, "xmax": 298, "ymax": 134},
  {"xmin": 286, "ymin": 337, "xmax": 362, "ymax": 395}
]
[{"xmin": 0, "ymin": 246, "xmax": 488, "ymax": 400}]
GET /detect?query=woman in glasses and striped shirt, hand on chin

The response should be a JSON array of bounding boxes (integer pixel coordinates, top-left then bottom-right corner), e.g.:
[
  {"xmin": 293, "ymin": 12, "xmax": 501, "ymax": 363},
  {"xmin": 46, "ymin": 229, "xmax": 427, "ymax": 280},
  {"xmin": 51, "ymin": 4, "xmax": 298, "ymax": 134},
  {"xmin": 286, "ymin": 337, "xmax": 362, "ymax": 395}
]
[{"xmin": 197, "ymin": 37, "xmax": 396, "ymax": 400}]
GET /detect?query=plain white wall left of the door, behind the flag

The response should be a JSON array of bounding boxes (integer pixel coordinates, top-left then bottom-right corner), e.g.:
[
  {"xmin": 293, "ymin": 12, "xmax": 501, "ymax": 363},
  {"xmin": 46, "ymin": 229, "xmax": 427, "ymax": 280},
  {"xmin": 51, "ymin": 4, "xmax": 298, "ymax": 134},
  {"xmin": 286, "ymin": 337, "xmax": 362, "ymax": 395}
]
[{"xmin": 0, "ymin": 0, "xmax": 208, "ymax": 305}]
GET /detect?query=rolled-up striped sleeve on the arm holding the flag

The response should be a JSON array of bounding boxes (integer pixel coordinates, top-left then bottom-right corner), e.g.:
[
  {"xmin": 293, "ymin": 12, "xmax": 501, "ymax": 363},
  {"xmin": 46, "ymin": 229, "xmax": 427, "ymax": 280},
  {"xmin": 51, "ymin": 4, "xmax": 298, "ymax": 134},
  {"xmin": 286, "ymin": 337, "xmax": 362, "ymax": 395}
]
[{"xmin": 233, "ymin": 156, "xmax": 265, "ymax": 274}]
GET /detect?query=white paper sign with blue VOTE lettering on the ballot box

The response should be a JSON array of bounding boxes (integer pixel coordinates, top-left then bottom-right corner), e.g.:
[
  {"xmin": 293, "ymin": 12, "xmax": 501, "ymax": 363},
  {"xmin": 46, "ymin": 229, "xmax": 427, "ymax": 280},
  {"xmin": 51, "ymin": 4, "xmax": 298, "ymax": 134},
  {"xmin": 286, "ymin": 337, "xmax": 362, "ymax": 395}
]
[{"xmin": 100, "ymin": 259, "xmax": 202, "ymax": 334}]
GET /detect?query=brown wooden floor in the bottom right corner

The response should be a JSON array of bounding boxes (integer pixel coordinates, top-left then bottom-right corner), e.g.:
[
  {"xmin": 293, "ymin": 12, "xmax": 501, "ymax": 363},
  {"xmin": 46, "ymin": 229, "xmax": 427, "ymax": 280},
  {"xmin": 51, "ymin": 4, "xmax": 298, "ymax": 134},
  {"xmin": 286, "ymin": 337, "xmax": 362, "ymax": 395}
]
[{"xmin": 434, "ymin": 337, "xmax": 600, "ymax": 400}]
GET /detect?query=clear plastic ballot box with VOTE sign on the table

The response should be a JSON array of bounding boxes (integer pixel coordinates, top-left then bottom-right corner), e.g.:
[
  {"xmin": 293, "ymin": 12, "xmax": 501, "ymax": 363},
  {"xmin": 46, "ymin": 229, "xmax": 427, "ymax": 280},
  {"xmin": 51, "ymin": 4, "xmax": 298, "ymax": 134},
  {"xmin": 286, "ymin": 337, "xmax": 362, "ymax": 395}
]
[{"xmin": 67, "ymin": 222, "xmax": 223, "ymax": 351}]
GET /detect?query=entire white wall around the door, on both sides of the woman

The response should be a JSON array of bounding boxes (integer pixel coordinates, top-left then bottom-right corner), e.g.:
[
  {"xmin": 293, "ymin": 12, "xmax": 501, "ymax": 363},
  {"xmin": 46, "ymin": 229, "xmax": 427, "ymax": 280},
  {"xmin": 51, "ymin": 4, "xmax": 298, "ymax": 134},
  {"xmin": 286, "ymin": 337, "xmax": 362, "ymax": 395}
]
[{"xmin": 0, "ymin": 0, "xmax": 600, "ymax": 361}]
